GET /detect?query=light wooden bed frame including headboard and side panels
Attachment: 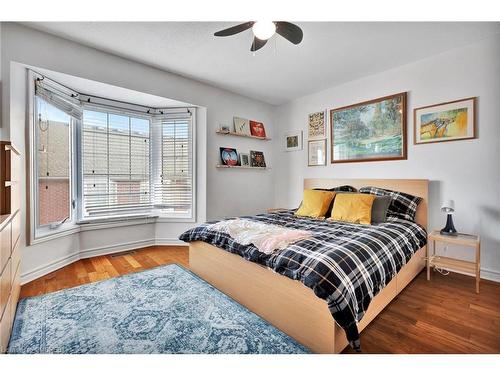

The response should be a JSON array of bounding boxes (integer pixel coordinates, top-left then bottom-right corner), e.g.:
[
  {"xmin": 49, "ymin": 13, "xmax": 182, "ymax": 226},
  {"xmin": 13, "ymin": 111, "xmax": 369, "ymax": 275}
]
[{"xmin": 189, "ymin": 179, "xmax": 429, "ymax": 353}]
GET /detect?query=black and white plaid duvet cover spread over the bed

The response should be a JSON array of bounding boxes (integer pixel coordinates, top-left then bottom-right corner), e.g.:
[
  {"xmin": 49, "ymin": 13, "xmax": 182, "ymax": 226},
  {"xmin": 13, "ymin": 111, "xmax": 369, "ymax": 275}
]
[{"xmin": 179, "ymin": 210, "xmax": 427, "ymax": 349}]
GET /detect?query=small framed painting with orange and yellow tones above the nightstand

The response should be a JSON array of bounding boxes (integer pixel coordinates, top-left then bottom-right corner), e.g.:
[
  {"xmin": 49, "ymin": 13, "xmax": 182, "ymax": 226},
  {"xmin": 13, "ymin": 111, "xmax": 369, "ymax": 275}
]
[{"xmin": 413, "ymin": 98, "xmax": 476, "ymax": 145}]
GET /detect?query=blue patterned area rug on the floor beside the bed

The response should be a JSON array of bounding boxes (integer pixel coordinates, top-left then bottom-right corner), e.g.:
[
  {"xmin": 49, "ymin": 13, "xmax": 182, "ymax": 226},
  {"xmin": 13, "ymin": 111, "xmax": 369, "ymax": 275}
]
[{"xmin": 8, "ymin": 264, "xmax": 308, "ymax": 354}]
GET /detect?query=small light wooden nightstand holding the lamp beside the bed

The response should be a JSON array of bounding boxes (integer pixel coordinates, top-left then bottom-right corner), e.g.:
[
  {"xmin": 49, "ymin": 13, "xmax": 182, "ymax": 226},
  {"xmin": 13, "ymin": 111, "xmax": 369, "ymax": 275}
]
[{"xmin": 427, "ymin": 230, "xmax": 481, "ymax": 293}]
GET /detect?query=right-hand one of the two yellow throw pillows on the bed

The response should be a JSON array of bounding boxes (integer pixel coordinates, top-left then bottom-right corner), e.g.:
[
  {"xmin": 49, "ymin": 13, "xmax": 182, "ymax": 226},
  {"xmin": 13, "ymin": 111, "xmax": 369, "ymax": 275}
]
[{"xmin": 330, "ymin": 194, "xmax": 375, "ymax": 225}]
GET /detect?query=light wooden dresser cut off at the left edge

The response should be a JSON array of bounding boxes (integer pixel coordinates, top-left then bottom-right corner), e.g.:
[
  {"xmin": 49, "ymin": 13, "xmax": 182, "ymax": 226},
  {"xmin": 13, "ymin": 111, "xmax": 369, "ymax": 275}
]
[{"xmin": 0, "ymin": 142, "xmax": 21, "ymax": 353}]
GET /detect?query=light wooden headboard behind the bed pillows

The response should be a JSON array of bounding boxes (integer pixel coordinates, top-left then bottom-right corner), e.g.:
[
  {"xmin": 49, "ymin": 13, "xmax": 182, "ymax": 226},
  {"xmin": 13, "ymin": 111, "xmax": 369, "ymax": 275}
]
[{"xmin": 304, "ymin": 178, "xmax": 429, "ymax": 230}]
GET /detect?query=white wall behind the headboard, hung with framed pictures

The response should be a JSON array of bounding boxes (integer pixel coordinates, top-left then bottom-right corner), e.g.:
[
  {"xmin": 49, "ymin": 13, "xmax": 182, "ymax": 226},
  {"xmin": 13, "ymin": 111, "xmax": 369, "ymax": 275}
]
[{"xmin": 275, "ymin": 36, "xmax": 500, "ymax": 279}]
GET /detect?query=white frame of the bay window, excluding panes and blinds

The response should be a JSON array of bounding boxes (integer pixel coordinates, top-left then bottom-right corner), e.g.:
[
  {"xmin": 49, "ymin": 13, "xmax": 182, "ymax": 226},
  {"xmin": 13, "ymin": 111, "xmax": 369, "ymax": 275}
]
[{"xmin": 26, "ymin": 69, "xmax": 198, "ymax": 245}]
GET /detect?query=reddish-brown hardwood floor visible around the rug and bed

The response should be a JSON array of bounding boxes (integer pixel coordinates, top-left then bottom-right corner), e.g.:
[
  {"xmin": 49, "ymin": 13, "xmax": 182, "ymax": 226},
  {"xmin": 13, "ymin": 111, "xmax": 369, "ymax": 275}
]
[{"xmin": 21, "ymin": 246, "xmax": 500, "ymax": 353}]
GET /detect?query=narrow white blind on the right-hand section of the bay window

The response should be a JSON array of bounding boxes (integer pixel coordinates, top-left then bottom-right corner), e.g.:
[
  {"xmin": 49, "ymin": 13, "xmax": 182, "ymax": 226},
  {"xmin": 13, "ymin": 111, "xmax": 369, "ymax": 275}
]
[{"xmin": 154, "ymin": 112, "xmax": 194, "ymax": 217}]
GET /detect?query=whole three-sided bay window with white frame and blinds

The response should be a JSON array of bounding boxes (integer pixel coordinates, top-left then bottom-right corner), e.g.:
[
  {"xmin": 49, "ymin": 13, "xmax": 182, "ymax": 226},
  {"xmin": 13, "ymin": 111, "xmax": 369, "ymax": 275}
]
[{"xmin": 30, "ymin": 73, "xmax": 195, "ymax": 242}]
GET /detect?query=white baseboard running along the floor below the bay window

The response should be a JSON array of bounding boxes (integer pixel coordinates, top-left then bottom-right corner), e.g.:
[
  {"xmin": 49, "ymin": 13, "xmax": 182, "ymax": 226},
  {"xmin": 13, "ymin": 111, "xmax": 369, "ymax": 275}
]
[{"xmin": 21, "ymin": 238, "xmax": 188, "ymax": 285}]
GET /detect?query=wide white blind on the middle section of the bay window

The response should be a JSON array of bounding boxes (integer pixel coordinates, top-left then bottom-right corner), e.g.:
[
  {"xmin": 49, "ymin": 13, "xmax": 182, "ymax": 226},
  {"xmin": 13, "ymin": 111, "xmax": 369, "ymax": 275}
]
[{"xmin": 81, "ymin": 109, "xmax": 152, "ymax": 217}]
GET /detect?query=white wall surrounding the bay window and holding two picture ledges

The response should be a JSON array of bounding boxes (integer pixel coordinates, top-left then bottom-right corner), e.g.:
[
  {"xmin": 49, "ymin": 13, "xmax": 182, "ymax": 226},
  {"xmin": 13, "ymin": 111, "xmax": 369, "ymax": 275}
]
[{"xmin": 1, "ymin": 23, "xmax": 274, "ymax": 279}]
